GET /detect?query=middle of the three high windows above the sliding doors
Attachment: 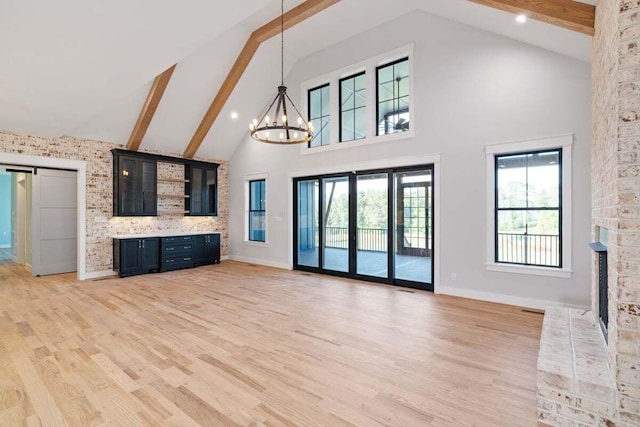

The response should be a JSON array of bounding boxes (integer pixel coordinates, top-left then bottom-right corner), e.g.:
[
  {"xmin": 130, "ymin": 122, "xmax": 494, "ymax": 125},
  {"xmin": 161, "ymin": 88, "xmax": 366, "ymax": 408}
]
[{"xmin": 340, "ymin": 72, "xmax": 367, "ymax": 142}]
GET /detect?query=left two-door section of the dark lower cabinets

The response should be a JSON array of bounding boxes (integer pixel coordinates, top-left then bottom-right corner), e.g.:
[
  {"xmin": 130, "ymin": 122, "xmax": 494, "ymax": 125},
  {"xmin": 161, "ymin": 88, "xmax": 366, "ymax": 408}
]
[{"xmin": 113, "ymin": 237, "xmax": 160, "ymax": 277}]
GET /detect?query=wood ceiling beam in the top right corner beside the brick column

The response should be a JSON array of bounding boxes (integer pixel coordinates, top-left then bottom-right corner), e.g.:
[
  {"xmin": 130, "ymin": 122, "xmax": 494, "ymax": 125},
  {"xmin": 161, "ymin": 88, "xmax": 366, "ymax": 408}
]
[{"xmin": 468, "ymin": 0, "xmax": 596, "ymax": 36}]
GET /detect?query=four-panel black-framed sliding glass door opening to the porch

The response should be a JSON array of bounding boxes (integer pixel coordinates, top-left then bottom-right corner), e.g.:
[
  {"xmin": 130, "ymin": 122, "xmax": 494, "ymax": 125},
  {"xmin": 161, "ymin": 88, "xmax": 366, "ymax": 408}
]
[{"xmin": 294, "ymin": 165, "xmax": 434, "ymax": 290}]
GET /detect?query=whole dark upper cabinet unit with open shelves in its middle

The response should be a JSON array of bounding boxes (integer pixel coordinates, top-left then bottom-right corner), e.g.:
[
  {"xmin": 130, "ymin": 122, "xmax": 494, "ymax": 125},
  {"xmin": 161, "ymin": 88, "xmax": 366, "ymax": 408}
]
[{"xmin": 111, "ymin": 149, "xmax": 218, "ymax": 216}]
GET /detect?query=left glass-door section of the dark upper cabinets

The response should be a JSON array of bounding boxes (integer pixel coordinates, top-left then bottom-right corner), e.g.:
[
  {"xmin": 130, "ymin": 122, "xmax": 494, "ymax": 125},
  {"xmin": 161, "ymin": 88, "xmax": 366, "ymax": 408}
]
[{"xmin": 113, "ymin": 155, "xmax": 158, "ymax": 216}]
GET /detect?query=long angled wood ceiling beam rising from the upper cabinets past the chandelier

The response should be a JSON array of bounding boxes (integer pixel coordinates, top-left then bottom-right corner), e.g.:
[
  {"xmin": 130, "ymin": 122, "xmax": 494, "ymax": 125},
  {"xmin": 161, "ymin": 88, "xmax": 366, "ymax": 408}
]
[{"xmin": 183, "ymin": 0, "xmax": 340, "ymax": 159}]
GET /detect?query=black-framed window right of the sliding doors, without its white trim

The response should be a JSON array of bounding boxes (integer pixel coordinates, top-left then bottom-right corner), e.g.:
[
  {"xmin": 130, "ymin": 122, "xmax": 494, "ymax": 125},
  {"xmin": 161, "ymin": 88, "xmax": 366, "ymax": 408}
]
[{"xmin": 495, "ymin": 149, "xmax": 562, "ymax": 268}]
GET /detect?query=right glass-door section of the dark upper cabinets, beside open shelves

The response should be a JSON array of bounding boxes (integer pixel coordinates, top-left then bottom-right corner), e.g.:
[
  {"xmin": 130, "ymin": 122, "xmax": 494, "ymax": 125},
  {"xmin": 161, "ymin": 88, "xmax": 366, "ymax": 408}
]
[{"xmin": 185, "ymin": 164, "xmax": 218, "ymax": 216}]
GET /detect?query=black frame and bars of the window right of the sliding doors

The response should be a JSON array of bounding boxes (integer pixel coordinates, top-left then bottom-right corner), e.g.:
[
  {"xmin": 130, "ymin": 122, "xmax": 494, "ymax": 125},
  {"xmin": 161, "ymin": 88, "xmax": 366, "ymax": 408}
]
[{"xmin": 493, "ymin": 147, "xmax": 563, "ymax": 269}]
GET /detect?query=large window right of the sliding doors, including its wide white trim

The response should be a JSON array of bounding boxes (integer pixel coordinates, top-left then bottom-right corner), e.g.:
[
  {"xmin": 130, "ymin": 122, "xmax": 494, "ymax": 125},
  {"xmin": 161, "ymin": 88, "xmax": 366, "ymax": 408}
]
[{"xmin": 485, "ymin": 134, "xmax": 573, "ymax": 279}]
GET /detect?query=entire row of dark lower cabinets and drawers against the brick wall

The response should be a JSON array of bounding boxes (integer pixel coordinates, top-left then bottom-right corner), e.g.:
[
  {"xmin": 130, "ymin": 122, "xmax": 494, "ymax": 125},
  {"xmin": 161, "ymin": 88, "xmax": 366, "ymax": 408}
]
[{"xmin": 113, "ymin": 233, "xmax": 220, "ymax": 277}]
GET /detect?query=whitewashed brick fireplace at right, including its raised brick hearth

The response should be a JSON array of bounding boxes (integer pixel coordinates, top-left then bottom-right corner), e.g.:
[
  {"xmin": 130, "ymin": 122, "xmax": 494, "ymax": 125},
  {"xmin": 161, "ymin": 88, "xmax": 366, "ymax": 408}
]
[{"xmin": 538, "ymin": 0, "xmax": 640, "ymax": 427}]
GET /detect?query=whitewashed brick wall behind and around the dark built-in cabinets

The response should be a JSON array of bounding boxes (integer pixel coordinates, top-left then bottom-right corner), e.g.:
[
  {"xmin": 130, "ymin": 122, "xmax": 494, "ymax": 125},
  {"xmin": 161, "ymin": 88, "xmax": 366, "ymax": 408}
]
[{"xmin": 0, "ymin": 132, "xmax": 229, "ymax": 273}]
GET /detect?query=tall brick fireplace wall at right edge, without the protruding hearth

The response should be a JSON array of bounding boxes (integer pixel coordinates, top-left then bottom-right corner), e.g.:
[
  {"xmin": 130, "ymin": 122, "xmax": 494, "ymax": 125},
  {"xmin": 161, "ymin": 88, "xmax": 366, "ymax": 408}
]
[{"xmin": 592, "ymin": 0, "xmax": 640, "ymax": 426}]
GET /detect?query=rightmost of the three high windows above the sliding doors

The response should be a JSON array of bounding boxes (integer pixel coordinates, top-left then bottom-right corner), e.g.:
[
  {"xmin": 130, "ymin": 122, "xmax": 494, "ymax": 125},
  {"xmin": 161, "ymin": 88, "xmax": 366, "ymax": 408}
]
[{"xmin": 376, "ymin": 58, "xmax": 409, "ymax": 135}]
